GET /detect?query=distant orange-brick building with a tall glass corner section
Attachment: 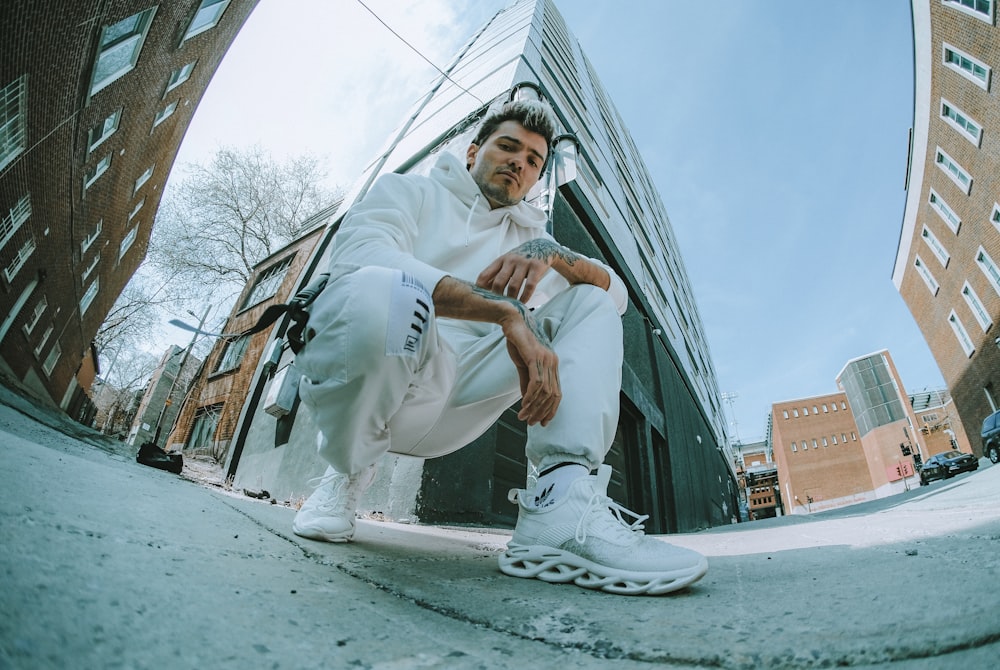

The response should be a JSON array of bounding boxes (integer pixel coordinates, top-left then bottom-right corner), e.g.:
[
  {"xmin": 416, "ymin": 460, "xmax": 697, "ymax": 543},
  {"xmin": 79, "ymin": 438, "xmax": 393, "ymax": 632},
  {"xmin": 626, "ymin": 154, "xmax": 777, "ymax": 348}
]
[{"xmin": 768, "ymin": 350, "xmax": 971, "ymax": 514}]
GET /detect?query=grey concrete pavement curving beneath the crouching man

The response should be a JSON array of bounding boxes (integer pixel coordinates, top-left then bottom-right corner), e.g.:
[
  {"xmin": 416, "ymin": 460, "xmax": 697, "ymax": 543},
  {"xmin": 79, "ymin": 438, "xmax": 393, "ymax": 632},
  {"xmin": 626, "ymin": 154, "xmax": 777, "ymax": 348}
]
[{"xmin": 0, "ymin": 390, "xmax": 1000, "ymax": 670}]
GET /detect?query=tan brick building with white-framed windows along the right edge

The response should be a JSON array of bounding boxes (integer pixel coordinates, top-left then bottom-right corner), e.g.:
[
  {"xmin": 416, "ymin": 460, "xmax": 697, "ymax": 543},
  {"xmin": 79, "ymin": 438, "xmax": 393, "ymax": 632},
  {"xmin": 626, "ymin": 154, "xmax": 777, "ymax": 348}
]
[{"xmin": 893, "ymin": 0, "xmax": 1000, "ymax": 455}]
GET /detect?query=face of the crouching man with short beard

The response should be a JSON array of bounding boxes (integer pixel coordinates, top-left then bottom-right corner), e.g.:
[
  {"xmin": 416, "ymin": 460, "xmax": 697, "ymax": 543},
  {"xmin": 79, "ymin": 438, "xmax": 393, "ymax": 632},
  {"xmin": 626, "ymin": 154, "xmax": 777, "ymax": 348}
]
[{"xmin": 466, "ymin": 121, "xmax": 548, "ymax": 208}]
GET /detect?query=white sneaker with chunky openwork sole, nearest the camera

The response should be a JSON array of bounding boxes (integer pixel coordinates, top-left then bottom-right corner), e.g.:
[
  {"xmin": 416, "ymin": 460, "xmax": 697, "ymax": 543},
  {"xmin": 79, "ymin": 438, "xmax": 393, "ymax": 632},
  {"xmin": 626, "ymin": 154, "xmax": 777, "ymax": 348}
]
[{"xmin": 500, "ymin": 465, "xmax": 708, "ymax": 595}]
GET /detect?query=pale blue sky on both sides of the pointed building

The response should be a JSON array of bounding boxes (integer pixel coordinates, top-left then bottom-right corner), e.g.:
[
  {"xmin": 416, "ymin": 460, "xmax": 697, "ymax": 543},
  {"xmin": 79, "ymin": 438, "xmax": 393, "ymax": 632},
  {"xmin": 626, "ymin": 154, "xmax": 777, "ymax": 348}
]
[{"xmin": 168, "ymin": 0, "xmax": 944, "ymax": 441}]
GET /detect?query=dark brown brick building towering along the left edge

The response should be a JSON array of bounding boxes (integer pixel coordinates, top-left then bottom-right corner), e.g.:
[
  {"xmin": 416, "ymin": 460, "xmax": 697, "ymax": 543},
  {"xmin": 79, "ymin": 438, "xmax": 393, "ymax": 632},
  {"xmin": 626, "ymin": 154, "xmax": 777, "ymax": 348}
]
[{"xmin": 0, "ymin": 0, "xmax": 256, "ymax": 421}]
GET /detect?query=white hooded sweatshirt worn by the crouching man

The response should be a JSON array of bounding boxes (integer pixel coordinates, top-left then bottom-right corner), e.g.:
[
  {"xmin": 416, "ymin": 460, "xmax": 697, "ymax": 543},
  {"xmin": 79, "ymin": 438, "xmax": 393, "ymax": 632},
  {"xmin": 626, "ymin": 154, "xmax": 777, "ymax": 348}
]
[{"xmin": 330, "ymin": 152, "xmax": 628, "ymax": 314}]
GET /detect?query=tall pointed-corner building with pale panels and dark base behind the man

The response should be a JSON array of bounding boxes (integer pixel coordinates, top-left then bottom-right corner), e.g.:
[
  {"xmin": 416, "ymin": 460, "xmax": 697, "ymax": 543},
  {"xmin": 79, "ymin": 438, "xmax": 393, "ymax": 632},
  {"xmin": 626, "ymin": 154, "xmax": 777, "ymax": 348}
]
[{"xmin": 228, "ymin": 0, "xmax": 737, "ymax": 532}]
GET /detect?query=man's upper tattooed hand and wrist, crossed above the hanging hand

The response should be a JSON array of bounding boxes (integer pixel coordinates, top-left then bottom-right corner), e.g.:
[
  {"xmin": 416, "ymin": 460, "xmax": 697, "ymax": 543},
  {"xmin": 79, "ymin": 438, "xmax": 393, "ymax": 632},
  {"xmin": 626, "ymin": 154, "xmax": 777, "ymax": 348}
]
[{"xmin": 476, "ymin": 238, "xmax": 611, "ymax": 303}]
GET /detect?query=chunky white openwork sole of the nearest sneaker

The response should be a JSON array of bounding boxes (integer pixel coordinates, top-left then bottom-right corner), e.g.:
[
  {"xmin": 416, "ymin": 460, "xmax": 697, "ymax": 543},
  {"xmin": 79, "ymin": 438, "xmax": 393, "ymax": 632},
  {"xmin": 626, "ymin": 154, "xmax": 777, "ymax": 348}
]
[{"xmin": 500, "ymin": 545, "xmax": 708, "ymax": 596}]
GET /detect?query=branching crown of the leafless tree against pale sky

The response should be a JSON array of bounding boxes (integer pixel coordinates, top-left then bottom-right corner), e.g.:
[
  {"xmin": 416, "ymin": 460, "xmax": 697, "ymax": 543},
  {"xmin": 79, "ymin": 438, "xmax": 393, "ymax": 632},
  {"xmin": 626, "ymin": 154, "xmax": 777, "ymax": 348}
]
[{"xmin": 148, "ymin": 147, "xmax": 334, "ymax": 308}]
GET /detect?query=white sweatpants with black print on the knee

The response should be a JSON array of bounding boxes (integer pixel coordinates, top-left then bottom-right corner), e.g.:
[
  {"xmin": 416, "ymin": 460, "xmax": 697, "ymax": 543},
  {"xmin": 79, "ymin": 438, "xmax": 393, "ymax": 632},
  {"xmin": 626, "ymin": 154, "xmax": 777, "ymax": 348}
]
[{"xmin": 295, "ymin": 267, "xmax": 623, "ymax": 473}]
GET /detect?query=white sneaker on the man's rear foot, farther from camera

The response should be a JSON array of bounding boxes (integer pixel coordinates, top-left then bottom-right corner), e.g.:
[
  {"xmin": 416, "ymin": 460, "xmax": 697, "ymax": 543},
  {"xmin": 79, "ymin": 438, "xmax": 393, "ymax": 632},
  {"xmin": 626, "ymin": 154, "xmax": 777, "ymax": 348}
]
[{"xmin": 292, "ymin": 465, "xmax": 375, "ymax": 542}]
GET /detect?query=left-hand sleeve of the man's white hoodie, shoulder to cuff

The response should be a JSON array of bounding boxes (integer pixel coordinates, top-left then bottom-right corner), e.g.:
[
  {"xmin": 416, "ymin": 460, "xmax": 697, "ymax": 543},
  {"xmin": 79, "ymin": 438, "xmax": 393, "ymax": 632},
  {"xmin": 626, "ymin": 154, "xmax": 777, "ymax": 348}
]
[{"xmin": 330, "ymin": 174, "xmax": 447, "ymax": 293}]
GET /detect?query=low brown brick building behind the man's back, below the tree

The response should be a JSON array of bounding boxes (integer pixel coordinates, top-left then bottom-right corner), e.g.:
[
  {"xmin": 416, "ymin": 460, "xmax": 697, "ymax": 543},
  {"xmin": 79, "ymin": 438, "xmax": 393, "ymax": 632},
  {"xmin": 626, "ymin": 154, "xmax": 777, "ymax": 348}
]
[{"xmin": 166, "ymin": 214, "xmax": 330, "ymax": 461}]
